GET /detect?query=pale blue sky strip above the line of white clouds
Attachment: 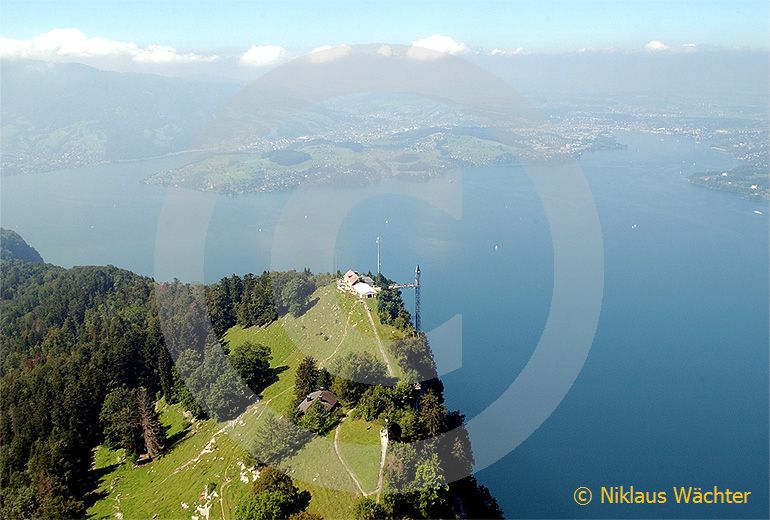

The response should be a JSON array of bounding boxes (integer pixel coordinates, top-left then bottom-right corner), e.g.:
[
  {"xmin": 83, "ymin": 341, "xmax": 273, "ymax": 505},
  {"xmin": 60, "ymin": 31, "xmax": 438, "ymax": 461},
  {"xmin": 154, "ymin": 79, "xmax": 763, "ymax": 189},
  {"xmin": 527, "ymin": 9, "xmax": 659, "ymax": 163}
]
[{"xmin": 0, "ymin": 0, "xmax": 770, "ymax": 54}]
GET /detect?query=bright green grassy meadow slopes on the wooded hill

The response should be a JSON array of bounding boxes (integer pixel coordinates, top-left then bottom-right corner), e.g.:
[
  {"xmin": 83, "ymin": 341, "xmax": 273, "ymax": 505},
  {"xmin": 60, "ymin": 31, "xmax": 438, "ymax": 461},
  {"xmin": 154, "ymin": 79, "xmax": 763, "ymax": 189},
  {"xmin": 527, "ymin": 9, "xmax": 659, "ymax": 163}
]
[{"xmin": 88, "ymin": 285, "xmax": 404, "ymax": 519}]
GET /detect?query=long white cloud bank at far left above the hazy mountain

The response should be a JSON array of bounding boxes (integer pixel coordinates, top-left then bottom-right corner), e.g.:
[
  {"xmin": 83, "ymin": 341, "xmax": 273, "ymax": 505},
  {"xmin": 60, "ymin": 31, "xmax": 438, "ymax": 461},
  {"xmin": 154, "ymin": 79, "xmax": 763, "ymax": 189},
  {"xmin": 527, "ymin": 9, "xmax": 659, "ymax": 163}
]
[{"xmin": 0, "ymin": 29, "xmax": 218, "ymax": 63}]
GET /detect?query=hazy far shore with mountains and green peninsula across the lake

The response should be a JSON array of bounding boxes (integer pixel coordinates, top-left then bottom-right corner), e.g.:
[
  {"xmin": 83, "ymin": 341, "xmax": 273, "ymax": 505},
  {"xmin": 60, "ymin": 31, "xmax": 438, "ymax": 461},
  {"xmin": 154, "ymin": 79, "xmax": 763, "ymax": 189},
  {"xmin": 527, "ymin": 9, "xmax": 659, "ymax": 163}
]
[{"xmin": 0, "ymin": 50, "xmax": 768, "ymax": 195}]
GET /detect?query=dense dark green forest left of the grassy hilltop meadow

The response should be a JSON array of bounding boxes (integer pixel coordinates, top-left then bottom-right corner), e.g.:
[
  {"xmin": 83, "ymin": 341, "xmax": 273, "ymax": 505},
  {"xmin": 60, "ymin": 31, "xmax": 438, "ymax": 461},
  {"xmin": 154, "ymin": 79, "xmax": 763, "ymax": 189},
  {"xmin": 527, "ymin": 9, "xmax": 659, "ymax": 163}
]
[{"xmin": 0, "ymin": 251, "xmax": 316, "ymax": 518}]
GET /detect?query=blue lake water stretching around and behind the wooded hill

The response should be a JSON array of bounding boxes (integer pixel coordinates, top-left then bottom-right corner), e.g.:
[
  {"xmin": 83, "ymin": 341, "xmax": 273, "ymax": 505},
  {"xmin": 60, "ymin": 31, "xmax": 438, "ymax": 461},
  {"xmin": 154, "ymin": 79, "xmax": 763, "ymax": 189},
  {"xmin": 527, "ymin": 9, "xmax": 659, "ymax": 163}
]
[{"xmin": 1, "ymin": 135, "xmax": 770, "ymax": 518}]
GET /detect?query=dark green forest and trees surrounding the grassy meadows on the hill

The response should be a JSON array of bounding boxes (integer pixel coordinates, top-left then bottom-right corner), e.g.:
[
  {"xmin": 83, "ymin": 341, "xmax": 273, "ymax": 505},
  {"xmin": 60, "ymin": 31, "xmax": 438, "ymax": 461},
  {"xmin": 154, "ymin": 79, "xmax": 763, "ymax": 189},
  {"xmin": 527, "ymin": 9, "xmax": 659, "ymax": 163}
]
[{"xmin": 0, "ymin": 232, "xmax": 501, "ymax": 518}]
